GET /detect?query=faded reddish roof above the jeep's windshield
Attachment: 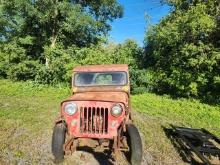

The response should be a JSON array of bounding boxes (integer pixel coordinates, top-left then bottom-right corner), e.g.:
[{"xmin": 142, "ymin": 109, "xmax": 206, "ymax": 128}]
[{"xmin": 73, "ymin": 64, "xmax": 128, "ymax": 72}]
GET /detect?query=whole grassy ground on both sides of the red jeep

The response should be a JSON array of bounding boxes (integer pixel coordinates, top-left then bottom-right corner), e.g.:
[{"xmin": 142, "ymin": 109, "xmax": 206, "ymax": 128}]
[{"xmin": 0, "ymin": 80, "xmax": 220, "ymax": 164}]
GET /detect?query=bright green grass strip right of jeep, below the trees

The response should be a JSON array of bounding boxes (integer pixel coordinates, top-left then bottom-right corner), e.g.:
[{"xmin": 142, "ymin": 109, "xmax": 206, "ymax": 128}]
[{"xmin": 132, "ymin": 93, "xmax": 220, "ymax": 136}]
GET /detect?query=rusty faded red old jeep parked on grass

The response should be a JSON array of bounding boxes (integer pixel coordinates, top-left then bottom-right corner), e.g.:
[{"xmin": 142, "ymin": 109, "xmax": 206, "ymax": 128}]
[{"xmin": 52, "ymin": 64, "xmax": 142, "ymax": 165}]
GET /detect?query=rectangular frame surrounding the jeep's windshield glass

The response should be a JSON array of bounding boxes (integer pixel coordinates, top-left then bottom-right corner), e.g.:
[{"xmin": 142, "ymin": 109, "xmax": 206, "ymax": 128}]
[{"xmin": 72, "ymin": 71, "xmax": 129, "ymax": 88}]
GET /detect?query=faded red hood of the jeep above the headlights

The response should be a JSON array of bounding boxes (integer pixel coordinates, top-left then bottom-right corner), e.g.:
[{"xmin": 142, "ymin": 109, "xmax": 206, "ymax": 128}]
[{"xmin": 64, "ymin": 92, "xmax": 128, "ymax": 104}]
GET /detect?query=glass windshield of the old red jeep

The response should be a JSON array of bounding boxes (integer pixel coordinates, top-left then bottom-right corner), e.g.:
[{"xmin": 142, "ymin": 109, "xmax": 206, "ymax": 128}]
[{"xmin": 74, "ymin": 72, "xmax": 127, "ymax": 86}]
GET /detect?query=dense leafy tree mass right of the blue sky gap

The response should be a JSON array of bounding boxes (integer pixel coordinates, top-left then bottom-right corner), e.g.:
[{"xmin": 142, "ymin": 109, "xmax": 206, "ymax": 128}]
[{"xmin": 145, "ymin": 0, "xmax": 220, "ymax": 101}]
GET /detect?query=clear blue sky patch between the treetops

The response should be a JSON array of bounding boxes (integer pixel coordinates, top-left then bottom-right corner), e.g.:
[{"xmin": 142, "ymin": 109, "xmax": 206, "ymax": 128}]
[{"xmin": 110, "ymin": 0, "xmax": 170, "ymax": 46}]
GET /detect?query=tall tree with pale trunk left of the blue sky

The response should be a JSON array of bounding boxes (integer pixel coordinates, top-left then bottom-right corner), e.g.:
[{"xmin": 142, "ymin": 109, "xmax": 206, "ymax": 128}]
[{"xmin": 0, "ymin": 0, "xmax": 122, "ymax": 66}]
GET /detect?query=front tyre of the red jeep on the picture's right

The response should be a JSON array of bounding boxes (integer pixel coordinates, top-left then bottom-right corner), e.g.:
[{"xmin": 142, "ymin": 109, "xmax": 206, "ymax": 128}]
[{"xmin": 127, "ymin": 124, "xmax": 142, "ymax": 165}]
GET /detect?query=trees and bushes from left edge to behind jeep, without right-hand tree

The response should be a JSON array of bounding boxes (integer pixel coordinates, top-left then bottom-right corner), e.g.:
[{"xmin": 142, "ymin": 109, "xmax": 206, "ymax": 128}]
[{"xmin": 0, "ymin": 0, "xmax": 148, "ymax": 91}]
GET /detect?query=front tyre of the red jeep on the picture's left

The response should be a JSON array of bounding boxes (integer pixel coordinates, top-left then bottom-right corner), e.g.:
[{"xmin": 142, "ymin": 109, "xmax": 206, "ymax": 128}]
[{"xmin": 52, "ymin": 123, "xmax": 66, "ymax": 163}]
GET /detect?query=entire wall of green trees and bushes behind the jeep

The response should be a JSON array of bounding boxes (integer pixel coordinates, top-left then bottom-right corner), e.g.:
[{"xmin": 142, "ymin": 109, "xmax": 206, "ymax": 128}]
[{"xmin": 0, "ymin": 0, "xmax": 220, "ymax": 102}]
